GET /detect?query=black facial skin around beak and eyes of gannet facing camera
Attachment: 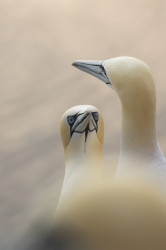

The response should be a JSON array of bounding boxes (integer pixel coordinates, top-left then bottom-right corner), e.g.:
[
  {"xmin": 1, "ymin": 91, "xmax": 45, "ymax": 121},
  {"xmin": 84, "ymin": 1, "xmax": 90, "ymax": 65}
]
[{"xmin": 67, "ymin": 112, "xmax": 99, "ymax": 142}]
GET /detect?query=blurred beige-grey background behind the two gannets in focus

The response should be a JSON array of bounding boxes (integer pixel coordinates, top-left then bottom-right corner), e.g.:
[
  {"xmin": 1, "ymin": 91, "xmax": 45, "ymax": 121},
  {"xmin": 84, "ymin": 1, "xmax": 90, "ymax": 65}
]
[{"xmin": 0, "ymin": 0, "xmax": 166, "ymax": 250}]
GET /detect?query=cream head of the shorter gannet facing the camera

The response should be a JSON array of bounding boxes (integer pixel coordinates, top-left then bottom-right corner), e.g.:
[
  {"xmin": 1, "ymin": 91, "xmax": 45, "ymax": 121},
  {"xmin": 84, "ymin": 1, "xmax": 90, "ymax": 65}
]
[{"xmin": 60, "ymin": 105, "xmax": 104, "ymax": 155}]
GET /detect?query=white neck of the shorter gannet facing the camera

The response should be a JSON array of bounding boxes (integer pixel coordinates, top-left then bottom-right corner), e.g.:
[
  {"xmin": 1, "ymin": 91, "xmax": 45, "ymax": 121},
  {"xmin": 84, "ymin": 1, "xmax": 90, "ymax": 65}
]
[{"xmin": 56, "ymin": 137, "xmax": 103, "ymax": 207}]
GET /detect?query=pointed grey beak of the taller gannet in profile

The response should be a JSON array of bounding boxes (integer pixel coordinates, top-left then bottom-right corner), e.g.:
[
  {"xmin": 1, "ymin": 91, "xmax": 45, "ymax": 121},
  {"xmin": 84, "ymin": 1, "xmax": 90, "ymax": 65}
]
[{"xmin": 72, "ymin": 60, "xmax": 111, "ymax": 84}]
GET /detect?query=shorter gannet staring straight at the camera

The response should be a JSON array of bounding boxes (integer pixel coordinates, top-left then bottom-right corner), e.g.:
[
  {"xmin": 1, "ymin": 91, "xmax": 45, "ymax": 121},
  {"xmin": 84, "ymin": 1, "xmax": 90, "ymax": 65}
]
[{"xmin": 59, "ymin": 105, "xmax": 104, "ymax": 204}]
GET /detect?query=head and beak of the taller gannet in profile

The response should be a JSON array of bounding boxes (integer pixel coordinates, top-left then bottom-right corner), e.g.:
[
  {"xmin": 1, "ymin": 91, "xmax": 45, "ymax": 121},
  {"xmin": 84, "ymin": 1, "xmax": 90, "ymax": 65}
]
[{"xmin": 73, "ymin": 56, "xmax": 155, "ymax": 112}]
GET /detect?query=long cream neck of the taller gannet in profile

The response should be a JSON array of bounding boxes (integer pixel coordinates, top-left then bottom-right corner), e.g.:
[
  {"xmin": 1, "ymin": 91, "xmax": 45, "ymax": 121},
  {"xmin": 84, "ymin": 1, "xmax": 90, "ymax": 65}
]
[{"xmin": 118, "ymin": 102, "xmax": 165, "ymax": 173}]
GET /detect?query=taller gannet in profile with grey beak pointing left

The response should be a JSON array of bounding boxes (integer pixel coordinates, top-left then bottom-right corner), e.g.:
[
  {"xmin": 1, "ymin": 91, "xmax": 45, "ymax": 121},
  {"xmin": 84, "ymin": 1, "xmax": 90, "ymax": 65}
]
[{"xmin": 73, "ymin": 56, "xmax": 166, "ymax": 181}]
